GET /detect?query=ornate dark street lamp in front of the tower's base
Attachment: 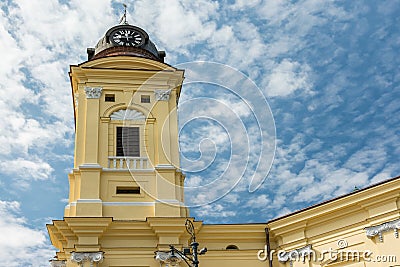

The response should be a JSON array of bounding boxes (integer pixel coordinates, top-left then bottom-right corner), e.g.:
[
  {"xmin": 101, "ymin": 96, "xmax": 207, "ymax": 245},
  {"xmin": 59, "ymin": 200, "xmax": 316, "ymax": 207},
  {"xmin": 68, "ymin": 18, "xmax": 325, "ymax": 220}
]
[{"xmin": 155, "ymin": 219, "xmax": 207, "ymax": 267}]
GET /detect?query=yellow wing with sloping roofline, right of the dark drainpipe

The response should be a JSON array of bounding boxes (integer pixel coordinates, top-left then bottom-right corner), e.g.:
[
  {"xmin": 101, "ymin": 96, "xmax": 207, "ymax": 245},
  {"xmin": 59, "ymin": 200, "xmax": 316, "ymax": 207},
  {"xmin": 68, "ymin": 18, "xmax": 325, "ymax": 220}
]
[{"xmin": 268, "ymin": 177, "xmax": 400, "ymax": 267}]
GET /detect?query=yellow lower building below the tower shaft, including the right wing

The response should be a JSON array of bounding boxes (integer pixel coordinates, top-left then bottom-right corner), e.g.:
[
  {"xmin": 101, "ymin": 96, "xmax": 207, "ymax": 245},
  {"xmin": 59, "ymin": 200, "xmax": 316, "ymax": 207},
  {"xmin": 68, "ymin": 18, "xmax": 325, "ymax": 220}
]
[{"xmin": 48, "ymin": 179, "xmax": 400, "ymax": 267}]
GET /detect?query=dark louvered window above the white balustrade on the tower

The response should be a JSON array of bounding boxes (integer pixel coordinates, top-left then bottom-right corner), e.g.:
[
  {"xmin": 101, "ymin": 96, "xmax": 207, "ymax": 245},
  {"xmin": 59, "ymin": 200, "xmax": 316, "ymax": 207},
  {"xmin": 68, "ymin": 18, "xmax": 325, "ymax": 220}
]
[{"xmin": 117, "ymin": 127, "xmax": 140, "ymax": 157}]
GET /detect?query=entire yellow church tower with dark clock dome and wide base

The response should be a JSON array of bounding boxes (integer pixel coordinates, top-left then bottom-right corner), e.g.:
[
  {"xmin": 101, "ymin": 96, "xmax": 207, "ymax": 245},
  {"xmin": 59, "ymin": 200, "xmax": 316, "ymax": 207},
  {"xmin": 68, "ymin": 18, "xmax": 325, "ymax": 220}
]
[{"xmin": 47, "ymin": 19, "xmax": 189, "ymax": 267}]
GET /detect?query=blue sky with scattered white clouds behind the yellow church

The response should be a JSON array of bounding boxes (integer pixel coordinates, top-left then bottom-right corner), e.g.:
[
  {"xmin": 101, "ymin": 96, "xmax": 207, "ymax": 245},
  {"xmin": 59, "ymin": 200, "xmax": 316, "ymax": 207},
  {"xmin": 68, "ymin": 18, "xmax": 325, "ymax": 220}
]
[{"xmin": 0, "ymin": 0, "xmax": 400, "ymax": 266}]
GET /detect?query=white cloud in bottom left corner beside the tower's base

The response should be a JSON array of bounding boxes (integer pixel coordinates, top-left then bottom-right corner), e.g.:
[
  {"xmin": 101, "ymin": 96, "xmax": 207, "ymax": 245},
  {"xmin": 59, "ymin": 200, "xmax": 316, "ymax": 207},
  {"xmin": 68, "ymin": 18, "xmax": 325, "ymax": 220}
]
[{"xmin": 0, "ymin": 200, "xmax": 55, "ymax": 267}]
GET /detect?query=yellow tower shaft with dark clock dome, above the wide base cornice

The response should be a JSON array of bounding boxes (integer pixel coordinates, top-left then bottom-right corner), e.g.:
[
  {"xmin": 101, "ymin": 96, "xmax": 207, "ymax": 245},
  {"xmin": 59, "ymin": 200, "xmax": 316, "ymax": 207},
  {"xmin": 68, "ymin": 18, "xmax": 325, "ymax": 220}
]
[{"xmin": 65, "ymin": 24, "xmax": 188, "ymax": 220}]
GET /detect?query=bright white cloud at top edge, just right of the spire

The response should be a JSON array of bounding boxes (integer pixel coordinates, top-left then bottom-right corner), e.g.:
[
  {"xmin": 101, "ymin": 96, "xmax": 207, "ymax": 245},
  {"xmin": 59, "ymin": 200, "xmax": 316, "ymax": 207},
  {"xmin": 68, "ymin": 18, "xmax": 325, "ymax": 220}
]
[{"xmin": 133, "ymin": 0, "xmax": 219, "ymax": 53}]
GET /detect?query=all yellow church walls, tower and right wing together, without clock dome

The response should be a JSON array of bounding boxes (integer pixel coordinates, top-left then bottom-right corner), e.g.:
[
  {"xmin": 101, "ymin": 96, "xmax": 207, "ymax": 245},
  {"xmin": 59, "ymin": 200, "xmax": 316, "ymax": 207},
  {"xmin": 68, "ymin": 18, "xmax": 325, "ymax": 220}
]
[{"xmin": 47, "ymin": 23, "xmax": 400, "ymax": 267}]
